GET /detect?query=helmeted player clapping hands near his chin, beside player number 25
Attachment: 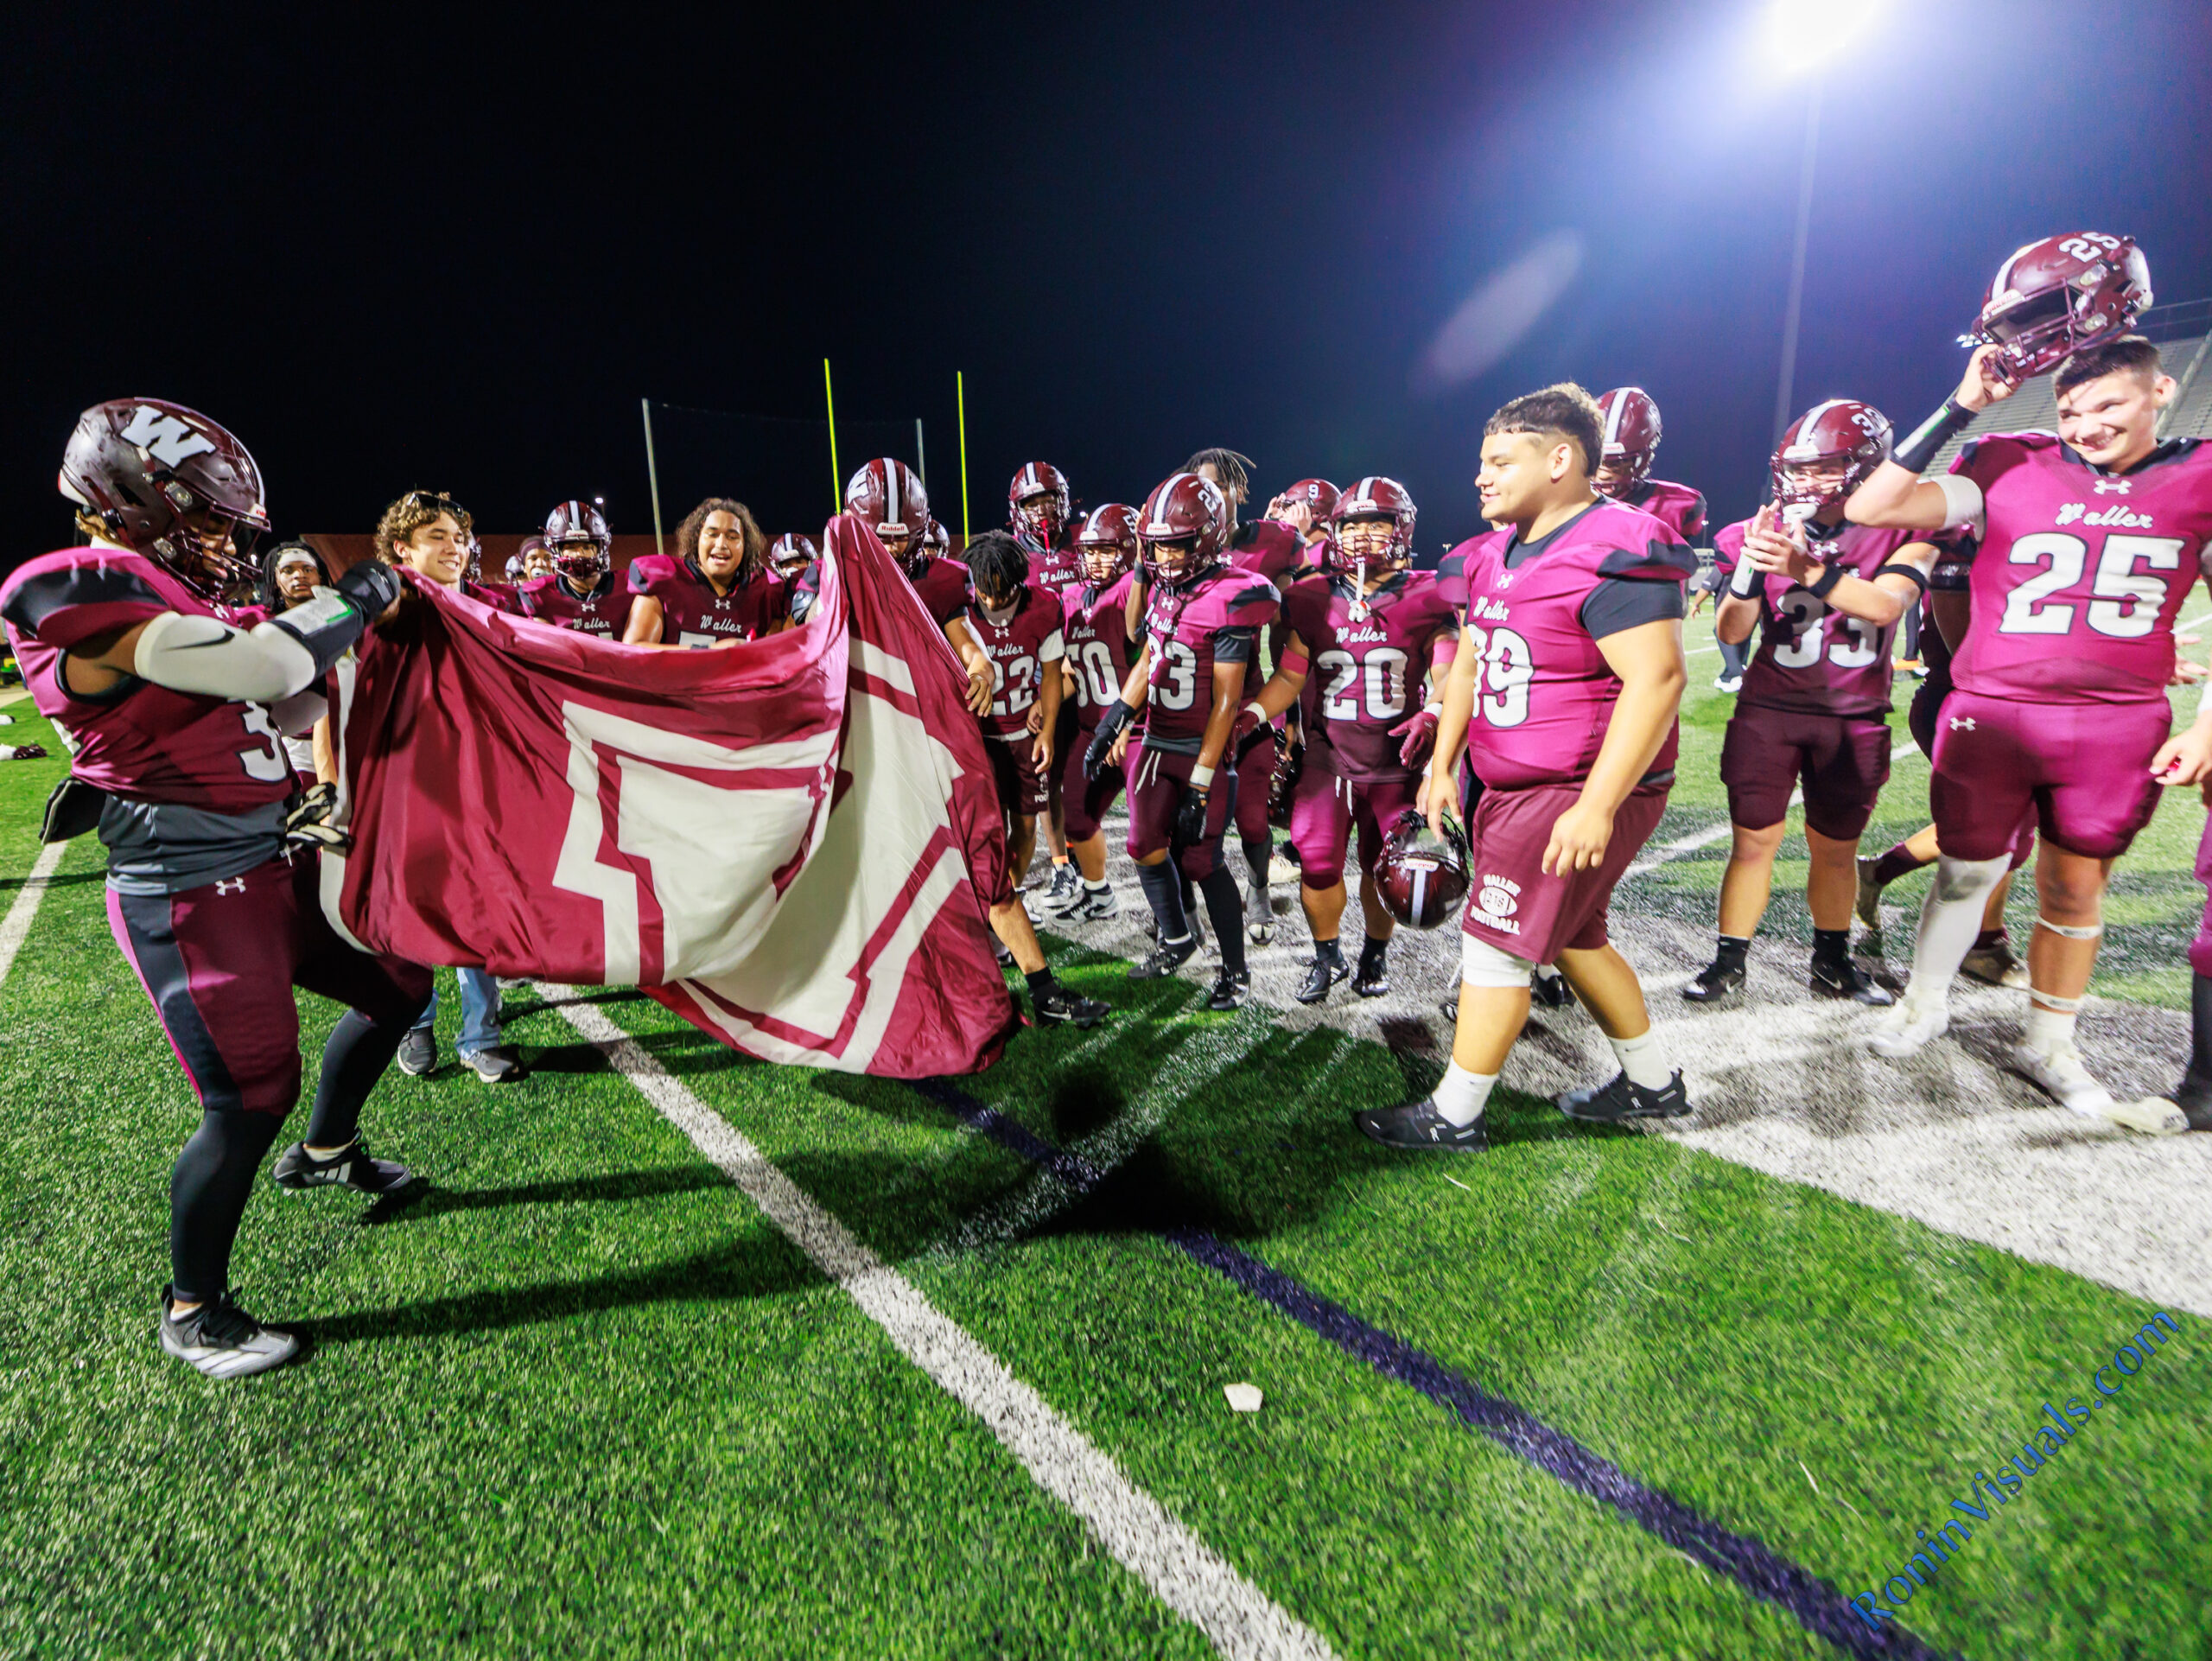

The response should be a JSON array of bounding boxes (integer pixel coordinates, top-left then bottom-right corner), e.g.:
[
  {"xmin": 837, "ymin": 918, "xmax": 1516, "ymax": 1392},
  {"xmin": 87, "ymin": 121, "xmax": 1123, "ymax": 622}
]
[{"xmin": 1681, "ymin": 411, "xmax": 1936, "ymax": 1004}]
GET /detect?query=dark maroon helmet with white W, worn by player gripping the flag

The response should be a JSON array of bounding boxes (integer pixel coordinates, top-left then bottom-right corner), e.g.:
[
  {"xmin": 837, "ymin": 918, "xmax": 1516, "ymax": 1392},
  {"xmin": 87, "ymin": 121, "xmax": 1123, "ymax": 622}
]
[{"xmin": 58, "ymin": 398, "xmax": 270, "ymax": 600}]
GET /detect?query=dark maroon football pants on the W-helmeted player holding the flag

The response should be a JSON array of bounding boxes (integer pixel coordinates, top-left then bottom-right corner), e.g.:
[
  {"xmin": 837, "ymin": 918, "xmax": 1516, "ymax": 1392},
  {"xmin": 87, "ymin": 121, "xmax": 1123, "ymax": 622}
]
[{"xmin": 108, "ymin": 858, "xmax": 429, "ymax": 1117}]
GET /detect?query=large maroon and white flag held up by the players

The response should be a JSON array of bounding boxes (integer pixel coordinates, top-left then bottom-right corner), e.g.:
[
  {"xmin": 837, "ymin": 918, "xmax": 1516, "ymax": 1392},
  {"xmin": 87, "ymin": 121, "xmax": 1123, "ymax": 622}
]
[{"xmin": 323, "ymin": 526, "xmax": 1015, "ymax": 1077}]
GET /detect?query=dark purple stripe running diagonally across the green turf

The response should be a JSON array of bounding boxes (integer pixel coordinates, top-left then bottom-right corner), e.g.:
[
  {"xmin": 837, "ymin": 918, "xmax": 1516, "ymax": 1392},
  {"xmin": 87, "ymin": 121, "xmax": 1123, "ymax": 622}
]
[{"xmin": 913, "ymin": 1079, "xmax": 1955, "ymax": 1661}]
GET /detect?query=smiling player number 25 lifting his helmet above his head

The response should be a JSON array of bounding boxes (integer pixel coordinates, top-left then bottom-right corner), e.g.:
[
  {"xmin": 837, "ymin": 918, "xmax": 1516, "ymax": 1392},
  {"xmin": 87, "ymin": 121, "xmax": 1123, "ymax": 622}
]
[{"xmin": 1849, "ymin": 232, "xmax": 2212, "ymax": 1117}]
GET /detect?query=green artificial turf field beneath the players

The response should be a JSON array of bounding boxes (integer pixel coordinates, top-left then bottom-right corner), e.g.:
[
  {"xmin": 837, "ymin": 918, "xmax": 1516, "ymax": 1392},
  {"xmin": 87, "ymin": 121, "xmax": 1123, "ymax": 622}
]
[{"xmin": 0, "ymin": 641, "xmax": 2212, "ymax": 1657}]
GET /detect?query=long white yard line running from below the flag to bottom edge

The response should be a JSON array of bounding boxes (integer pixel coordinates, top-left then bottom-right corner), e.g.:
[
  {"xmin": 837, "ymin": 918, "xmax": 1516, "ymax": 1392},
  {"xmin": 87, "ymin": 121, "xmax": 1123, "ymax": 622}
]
[{"xmin": 544, "ymin": 986, "xmax": 1334, "ymax": 1657}]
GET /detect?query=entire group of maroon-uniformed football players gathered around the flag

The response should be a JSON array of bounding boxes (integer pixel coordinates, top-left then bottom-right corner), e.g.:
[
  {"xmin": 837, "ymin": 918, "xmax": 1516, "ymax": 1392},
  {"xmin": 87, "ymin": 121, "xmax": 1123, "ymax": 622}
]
[{"xmin": 0, "ymin": 232, "xmax": 2212, "ymax": 1378}]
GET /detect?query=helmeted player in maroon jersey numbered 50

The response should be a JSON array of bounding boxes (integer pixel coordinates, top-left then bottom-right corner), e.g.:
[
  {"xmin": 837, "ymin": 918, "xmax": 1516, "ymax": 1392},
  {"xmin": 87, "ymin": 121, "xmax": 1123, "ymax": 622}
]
[{"xmin": 1046, "ymin": 502, "xmax": 1137, "ymax": 922}]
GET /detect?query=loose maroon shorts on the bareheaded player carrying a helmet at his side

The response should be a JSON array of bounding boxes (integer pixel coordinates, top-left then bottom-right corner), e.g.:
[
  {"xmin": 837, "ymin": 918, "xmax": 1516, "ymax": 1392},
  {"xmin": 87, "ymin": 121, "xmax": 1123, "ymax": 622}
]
[{"xmin": 1460, "ymin": 786, "xmax": 1668, "ymax": 962}]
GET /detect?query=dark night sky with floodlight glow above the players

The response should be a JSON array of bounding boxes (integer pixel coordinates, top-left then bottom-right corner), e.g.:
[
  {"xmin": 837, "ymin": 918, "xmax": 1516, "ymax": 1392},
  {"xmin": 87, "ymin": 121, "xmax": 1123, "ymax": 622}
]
[{"xmin": 0, "ymin": 0, "xmax": 2212, "ymax": 562}]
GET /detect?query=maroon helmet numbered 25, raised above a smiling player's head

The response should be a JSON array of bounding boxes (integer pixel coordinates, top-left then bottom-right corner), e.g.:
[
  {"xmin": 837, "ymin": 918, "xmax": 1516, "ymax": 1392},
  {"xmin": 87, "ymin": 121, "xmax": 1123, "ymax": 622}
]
[{"xmin": 1964, "ymin": 230, "xmax": 2150, "ymax": 387}]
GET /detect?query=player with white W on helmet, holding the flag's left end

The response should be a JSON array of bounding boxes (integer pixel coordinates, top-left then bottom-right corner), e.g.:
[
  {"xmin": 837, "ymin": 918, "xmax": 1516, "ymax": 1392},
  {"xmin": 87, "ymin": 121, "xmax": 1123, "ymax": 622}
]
[{"xmin": 0, "ymin": 398, "xmax": 429, "ymax": 1378}]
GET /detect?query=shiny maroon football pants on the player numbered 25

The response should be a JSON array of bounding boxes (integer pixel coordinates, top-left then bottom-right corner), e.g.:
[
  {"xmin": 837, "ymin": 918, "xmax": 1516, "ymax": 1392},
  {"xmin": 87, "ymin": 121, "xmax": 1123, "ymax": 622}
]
[{"xmin": 1929, "ymin": 690, "xmax": 2174, "ymax": 862}]
